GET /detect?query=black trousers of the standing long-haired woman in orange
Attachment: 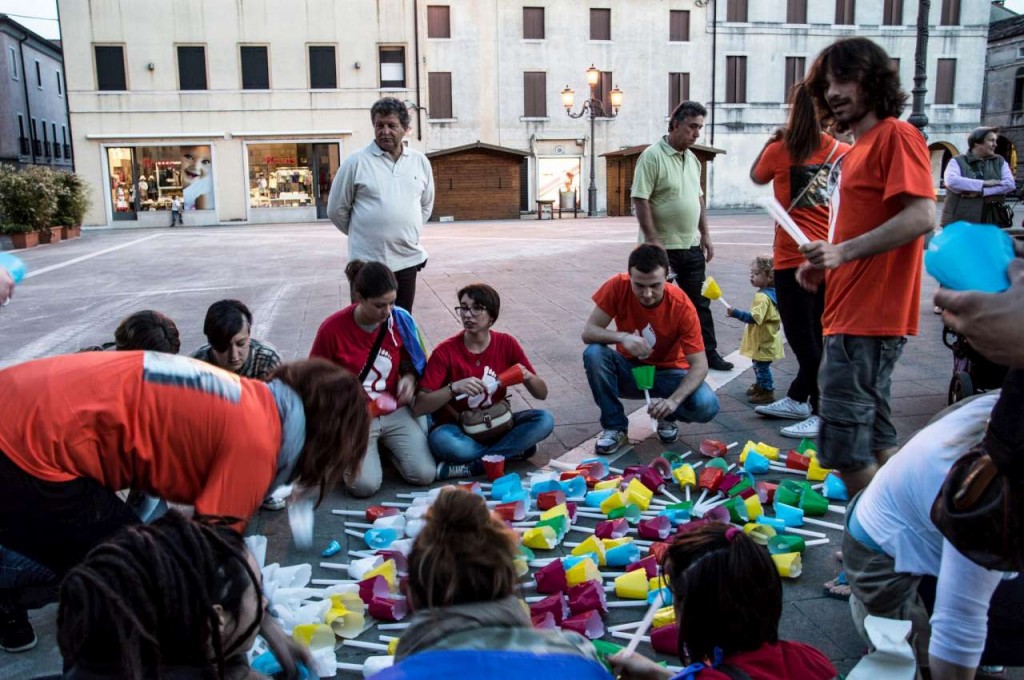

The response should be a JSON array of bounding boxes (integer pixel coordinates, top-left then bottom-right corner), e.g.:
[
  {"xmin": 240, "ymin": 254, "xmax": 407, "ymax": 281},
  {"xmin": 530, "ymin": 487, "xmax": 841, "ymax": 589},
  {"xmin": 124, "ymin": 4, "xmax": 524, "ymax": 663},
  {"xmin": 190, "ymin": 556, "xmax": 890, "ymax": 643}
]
[{"xmin": 775, "ymin": 268, "xmax": 825, "ymax": 413}]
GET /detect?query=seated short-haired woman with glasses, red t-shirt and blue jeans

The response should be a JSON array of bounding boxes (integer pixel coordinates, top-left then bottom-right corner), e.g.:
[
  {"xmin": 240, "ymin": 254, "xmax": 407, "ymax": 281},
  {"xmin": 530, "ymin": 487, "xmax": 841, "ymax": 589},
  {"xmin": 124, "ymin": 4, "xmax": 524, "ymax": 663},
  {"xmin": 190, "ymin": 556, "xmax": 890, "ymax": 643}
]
[{"xmin": 413, "ymin": 284, "xmax": 555, "ymax": 479}]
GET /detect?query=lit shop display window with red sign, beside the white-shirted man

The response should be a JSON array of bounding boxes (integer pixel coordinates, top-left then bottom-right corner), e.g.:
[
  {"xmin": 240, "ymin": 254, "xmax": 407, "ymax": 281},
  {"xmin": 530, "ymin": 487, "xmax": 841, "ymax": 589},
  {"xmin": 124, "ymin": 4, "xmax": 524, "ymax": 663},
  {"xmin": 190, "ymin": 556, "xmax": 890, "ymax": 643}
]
[{"xmin": 248, "ymin": 142, "xmax": 313, "ymax": 208}]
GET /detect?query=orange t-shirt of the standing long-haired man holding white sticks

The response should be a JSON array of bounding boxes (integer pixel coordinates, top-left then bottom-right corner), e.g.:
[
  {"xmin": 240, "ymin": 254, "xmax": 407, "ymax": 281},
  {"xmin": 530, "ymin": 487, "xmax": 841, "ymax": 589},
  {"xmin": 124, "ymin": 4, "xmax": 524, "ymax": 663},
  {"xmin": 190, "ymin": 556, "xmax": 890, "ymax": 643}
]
[{"xmin": 821, "ymin": 118, "xmax": 935, "ymax": 336}]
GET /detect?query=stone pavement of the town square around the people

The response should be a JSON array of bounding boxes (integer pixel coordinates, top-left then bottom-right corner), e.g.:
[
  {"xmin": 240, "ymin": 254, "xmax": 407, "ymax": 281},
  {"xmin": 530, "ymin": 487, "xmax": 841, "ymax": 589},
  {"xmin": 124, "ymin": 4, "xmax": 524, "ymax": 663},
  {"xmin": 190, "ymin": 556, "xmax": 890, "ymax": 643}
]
[{"xmin": 0, "ymin": 213, "xmax": 1007, "ymax": 678}]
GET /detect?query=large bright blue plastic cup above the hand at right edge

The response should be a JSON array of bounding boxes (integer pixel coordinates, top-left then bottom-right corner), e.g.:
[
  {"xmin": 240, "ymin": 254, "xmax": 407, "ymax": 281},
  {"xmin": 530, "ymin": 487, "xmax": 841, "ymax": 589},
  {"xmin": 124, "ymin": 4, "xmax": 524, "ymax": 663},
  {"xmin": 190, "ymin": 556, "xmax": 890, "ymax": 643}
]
[{"xmin": 925, "ymin": 221, "xmax": 1014, "ymax": 293}]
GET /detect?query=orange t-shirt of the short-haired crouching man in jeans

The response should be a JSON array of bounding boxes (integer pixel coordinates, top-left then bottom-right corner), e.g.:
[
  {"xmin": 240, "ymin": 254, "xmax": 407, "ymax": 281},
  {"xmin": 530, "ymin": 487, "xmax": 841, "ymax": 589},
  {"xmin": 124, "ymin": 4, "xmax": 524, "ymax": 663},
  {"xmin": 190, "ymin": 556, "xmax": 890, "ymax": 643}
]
[{"xmin": 592, "ymin": 273, "xmax": 703, "ymax": 369}]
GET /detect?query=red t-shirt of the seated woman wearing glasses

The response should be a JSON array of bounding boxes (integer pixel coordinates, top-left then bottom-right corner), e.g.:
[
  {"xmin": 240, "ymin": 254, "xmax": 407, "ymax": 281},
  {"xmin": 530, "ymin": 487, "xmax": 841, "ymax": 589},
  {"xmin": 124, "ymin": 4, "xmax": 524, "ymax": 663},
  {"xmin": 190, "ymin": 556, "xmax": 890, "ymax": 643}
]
[{"xmin": 420, "ymin": 331, "xmax": 536, "ymax": 423}]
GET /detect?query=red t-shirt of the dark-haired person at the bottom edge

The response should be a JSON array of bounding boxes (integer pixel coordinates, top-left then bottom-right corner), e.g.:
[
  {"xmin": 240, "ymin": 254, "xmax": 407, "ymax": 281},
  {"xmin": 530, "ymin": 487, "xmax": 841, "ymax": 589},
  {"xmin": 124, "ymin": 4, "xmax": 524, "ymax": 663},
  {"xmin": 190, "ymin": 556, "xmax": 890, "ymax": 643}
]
[{"xmin": 696, "ymin": 640, "xmax": 839, "ymax": 680}]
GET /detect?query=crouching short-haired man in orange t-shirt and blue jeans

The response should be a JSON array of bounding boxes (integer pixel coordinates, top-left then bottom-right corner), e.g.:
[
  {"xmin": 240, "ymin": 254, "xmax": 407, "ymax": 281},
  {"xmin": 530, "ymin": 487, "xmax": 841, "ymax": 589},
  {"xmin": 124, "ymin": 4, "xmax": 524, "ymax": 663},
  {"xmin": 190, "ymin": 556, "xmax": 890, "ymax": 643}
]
[{"xmin": 583, "ymin": 244, "xmax": 719, "ymax": 455}]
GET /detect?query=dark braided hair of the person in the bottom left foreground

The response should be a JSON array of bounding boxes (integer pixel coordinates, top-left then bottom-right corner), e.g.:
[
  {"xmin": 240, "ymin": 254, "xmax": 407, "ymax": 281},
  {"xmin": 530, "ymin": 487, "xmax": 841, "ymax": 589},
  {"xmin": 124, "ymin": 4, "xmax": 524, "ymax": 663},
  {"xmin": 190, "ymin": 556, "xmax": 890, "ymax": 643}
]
[{"xmin": 57, "ymin": 510, "xmax": 263, "ymax": 680}]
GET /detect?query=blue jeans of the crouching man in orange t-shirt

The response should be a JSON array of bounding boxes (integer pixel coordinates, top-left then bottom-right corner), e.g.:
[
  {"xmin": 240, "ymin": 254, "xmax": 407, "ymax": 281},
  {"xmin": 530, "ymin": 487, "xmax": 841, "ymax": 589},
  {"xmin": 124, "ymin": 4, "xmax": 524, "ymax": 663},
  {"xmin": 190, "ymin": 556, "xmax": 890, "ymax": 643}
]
[{"xmin": 583, "ymin": 344, "xmax": 719, "ymax": 432}]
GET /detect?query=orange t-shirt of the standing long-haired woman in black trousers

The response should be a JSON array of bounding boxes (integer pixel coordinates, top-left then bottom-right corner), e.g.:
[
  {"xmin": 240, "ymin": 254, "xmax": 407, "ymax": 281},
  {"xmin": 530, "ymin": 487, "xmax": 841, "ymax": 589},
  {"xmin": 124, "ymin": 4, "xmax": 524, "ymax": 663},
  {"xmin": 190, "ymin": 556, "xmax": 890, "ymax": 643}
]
[{"xmin": 754, "ymin": 132, "xmax": 850, "ymax": 269}]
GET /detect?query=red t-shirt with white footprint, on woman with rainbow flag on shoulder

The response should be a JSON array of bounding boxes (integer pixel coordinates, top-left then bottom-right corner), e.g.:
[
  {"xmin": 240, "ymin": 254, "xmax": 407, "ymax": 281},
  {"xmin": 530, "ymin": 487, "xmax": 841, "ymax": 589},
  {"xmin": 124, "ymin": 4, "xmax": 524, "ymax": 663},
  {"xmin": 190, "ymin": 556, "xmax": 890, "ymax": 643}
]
[{"xmin": 309, "ymin": 304, "xmax": 408, "ymax": 400}]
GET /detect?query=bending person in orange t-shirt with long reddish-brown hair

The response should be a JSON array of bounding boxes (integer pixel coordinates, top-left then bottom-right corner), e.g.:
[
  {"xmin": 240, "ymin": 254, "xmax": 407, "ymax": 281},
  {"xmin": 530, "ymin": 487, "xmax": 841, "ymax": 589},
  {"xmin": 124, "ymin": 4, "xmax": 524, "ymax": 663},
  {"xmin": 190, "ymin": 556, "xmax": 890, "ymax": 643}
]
[{"xmin": 0, "ymin": 351, "xmax": 370, "ymax": 663}]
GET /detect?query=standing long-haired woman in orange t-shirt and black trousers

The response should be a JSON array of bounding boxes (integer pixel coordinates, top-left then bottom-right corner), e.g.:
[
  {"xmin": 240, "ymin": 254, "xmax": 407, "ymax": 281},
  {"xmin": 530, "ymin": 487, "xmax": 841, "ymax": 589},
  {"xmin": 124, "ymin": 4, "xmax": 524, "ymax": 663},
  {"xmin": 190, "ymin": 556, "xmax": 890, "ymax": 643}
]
[{"xmin": 751, "ymin": 83, "xmax": 850, "ymax": 439}]
